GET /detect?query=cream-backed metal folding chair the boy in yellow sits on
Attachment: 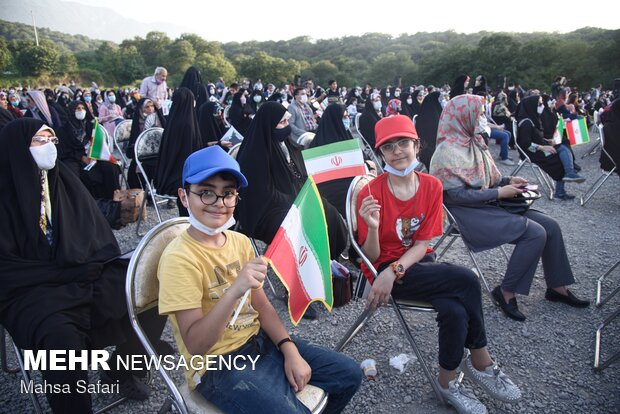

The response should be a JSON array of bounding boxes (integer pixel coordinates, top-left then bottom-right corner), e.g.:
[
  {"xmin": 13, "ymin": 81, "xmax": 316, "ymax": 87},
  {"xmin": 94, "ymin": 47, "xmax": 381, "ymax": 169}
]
[{"xmin": 125, "ymin": 217, "xmax": 327, "ymax": 414}]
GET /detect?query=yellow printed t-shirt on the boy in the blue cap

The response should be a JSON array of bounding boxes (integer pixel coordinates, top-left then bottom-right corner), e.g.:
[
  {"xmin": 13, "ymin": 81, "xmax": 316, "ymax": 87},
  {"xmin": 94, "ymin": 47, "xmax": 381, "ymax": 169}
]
[{"xmin": 157, "ymin": 231, "xmax": 260, "ymax": 389}]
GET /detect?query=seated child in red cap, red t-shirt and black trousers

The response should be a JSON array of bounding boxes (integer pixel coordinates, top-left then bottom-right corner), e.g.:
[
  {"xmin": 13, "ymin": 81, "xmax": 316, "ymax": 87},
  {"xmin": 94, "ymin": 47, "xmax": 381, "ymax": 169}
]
[{"xmin": 358, "ymin": 115, "xmax": 521, "ymax": 413}]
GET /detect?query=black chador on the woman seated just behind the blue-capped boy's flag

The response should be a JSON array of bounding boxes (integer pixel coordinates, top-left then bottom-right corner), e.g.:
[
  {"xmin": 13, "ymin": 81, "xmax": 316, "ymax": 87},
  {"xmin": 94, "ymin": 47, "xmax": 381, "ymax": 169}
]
[{"xmin": 236, "ymin": 102, "xmax": 306, "ymax": 235}]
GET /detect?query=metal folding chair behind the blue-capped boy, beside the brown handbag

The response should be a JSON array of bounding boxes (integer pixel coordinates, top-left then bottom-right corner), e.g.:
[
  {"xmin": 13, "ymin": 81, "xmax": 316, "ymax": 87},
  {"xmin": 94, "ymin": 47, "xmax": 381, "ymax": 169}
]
[{"xmin": 134, "ymin": 128, "xmax": 177, "ymax": 236}]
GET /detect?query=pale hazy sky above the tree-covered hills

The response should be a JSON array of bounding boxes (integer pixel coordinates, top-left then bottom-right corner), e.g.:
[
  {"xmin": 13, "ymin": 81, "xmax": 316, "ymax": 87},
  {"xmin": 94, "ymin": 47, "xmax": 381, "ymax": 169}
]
[{"xmin": 71, "ymin": 0, "xmax": 620, "ymax": 42}]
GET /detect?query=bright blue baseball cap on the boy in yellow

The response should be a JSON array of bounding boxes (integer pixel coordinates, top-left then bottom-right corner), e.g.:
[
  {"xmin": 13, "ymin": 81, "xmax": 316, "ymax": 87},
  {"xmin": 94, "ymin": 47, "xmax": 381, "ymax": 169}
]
[{"xmin": 181, "ymin": 145, "xmax": 248, "ymax": 187}]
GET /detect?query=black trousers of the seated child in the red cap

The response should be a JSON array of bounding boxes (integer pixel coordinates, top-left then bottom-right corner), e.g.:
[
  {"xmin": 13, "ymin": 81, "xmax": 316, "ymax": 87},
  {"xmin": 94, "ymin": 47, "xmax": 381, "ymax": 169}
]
[{"xmin": 379, "ymin": 255, "xmax": 487, "ymax": 371}]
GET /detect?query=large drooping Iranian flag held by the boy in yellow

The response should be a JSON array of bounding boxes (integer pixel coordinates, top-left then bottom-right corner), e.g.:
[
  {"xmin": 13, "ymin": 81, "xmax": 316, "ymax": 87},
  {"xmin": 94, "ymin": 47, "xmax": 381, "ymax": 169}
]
[{"xmin": 264, "ymin": 177, "xmax": 333, "ymax": 325}]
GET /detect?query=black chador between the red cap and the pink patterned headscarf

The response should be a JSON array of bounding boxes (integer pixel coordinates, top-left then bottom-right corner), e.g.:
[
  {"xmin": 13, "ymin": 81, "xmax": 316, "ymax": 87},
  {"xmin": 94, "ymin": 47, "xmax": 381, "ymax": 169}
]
[{"xmin": 415, "ymin": 91, "xmax": 442, "ymax": 168}]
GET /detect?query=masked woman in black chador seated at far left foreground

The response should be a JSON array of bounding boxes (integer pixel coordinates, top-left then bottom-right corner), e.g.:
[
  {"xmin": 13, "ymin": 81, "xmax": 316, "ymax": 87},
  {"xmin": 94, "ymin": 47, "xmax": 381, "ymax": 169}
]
[{"xmin": 0, "ymin": 118, "xmax": 165, "ymax": 413}]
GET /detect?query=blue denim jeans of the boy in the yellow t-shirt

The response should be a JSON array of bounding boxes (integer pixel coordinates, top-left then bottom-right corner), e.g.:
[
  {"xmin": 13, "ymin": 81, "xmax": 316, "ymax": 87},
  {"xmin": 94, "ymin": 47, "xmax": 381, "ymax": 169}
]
[{"xmin": 196, "ymin": 330, "xmax": 362, "ymax": 414}]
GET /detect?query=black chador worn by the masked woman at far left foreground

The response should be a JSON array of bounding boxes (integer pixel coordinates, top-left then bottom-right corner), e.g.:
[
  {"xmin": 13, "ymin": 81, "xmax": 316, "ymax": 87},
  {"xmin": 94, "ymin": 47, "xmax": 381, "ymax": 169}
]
[{"xmin": 0, "ymin": 118, "xmax": 126, "ymax": 344}]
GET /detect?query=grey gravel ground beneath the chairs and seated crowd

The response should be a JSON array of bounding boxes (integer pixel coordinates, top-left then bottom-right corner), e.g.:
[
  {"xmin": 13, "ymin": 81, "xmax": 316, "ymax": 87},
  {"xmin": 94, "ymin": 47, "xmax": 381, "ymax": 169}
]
[{"xmin": 0, "ymin": 128, "xmax": 620, "ymax": 413}]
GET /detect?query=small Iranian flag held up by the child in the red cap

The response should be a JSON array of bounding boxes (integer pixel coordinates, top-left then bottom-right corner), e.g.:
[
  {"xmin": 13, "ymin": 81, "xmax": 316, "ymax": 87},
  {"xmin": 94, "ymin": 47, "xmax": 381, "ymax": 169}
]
[{"xmin": 301, "ymin": 139, "xmax": 366, "ymax": 184}]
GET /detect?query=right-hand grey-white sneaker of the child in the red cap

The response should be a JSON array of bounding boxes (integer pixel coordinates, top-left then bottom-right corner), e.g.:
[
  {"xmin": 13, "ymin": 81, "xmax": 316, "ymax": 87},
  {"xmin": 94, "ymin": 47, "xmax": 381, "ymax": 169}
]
[{"xmin": 461, "ymin": 356, "xmax": 521, "ymax": 403}]
